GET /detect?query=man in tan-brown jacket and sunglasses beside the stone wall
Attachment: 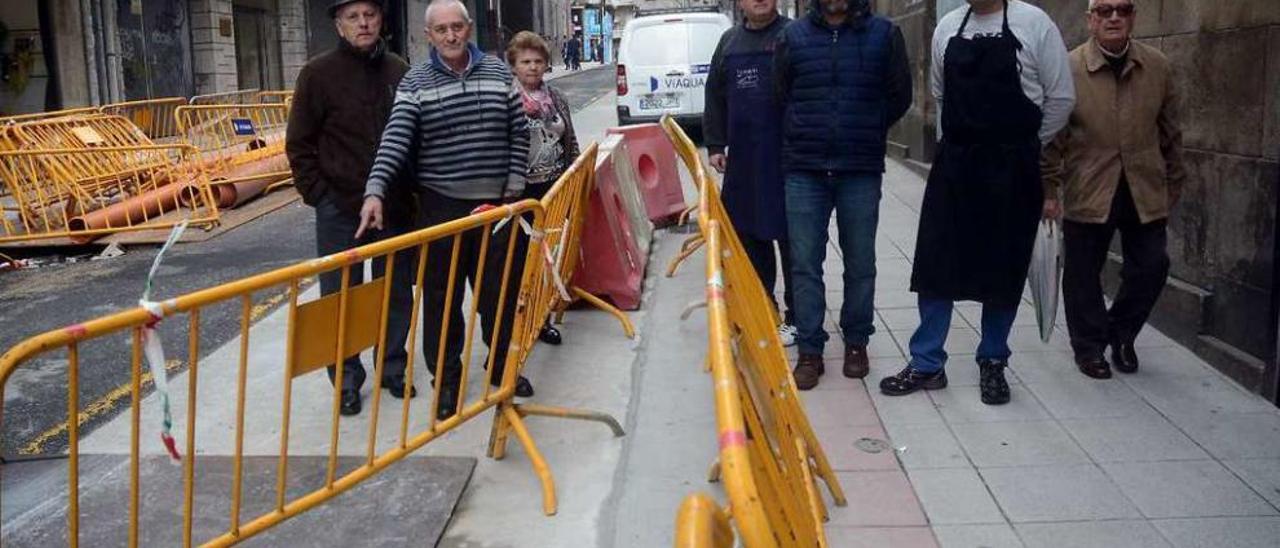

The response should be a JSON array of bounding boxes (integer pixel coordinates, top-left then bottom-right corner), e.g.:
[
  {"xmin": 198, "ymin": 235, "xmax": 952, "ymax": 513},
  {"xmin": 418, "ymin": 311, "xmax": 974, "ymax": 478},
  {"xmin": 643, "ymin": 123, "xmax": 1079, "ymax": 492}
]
[{"xmin": 1043, "ymin": 0, "xmax": 1187, "ymax": 379}]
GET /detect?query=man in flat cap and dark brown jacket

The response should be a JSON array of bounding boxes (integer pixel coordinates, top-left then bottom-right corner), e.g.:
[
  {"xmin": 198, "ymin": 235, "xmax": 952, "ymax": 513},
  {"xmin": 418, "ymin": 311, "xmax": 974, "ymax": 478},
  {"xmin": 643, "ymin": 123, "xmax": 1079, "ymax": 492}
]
[{"xmin": 285, "ymin": 0, "xmax": 413, "ymax": 415}]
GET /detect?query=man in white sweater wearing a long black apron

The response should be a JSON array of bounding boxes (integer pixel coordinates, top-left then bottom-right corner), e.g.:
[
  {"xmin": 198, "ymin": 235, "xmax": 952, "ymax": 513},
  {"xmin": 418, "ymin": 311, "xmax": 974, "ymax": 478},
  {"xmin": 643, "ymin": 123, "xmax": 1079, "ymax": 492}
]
[{"xmin": 881, "ymin": 0, "xmax": 1075, "ymax": 405}]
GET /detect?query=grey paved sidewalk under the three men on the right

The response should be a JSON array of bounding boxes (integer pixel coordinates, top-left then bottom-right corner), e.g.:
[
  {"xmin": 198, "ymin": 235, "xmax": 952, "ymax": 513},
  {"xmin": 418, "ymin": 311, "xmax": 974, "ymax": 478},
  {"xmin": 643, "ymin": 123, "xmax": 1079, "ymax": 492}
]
[{"xmin": 792, "ymin": 161, "xmax": 1280, "ymax": 547}]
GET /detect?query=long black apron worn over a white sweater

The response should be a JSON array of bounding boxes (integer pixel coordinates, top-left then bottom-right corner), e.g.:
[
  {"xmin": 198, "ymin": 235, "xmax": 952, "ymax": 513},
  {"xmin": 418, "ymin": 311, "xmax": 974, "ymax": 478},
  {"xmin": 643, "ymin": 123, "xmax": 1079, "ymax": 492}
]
[{"xmin": 911, "ymin": 1, "xmax": 1044, "ymax": 306}]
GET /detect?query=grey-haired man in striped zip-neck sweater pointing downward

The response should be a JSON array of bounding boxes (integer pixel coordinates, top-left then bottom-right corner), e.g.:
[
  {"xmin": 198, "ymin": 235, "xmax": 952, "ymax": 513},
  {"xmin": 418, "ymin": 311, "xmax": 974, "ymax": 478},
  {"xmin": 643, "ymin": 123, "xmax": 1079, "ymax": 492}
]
[{"xmin": 360, "ymin": 0, "xmax": 534, "ymax": 419}]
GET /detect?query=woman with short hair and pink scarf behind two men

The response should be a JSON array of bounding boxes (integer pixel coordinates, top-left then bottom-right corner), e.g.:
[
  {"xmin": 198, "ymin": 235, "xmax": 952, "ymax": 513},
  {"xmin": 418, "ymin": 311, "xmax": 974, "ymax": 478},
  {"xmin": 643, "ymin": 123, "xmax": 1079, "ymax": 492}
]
[{"xmin": 507, "ymin": 31, "xmax": 579, "ymax": 344}]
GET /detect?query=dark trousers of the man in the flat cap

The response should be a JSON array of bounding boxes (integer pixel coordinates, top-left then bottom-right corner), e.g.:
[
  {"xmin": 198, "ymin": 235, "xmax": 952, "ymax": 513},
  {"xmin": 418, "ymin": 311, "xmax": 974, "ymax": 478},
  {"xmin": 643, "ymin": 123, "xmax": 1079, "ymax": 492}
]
[{"xmin": 316, "ymin": 197, "xmax": 417, "ymax": 391}]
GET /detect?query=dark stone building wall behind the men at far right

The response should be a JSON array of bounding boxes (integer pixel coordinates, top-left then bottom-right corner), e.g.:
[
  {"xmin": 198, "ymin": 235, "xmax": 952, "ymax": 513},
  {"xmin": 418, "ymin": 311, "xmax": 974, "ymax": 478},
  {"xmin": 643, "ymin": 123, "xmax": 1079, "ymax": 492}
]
[{"xmin": 876, "ymin": 0, "xmax": 1280, "ymax": 398}]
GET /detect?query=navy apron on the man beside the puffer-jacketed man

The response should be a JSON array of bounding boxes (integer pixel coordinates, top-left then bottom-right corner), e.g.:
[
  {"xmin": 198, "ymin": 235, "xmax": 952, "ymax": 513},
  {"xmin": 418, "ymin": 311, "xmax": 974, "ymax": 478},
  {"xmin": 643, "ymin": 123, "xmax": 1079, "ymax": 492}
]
[{"xmin": 722, "ymin": 46, "xmax": 787, "ymax": 239}]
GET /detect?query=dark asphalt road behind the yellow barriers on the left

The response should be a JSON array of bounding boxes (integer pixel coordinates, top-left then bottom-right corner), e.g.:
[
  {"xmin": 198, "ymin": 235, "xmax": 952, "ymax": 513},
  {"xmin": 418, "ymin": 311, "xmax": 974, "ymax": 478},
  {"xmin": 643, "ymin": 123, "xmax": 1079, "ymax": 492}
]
[{"xmin": 0, "ymin": 67, "xmax": 614, "ymax": 458}]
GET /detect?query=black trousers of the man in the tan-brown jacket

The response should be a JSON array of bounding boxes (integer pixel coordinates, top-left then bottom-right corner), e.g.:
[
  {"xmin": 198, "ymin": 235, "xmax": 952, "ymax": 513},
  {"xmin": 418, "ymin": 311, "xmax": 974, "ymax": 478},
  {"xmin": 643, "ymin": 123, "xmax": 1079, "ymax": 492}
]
[{"xmin": 1062, "ymin": 179, "xmax": 1169, "ymax": 359}]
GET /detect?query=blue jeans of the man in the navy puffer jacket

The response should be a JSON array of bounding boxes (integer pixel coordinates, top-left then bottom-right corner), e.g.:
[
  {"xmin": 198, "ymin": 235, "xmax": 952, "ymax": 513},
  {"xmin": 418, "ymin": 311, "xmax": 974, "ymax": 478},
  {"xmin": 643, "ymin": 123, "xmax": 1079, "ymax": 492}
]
[{"xmin": 786, "ymin": 172, "xmax": 882, "ymax": 355}]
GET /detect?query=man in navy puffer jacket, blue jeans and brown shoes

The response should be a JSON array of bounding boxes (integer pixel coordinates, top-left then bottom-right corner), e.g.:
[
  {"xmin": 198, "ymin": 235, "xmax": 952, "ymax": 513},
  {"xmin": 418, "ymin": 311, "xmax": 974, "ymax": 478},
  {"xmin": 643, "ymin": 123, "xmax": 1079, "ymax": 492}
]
[{"xmin": 774, "ymin": 0, "xmax": 911, "ymax": 389}]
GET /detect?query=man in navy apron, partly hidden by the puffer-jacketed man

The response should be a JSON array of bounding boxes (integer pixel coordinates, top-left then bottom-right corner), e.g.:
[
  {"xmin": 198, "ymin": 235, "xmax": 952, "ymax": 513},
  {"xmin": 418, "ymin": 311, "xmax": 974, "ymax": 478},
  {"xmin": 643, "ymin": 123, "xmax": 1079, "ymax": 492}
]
[{"xmin": 703, "ymin": 0, "xmax": 795, "ymax": 346}]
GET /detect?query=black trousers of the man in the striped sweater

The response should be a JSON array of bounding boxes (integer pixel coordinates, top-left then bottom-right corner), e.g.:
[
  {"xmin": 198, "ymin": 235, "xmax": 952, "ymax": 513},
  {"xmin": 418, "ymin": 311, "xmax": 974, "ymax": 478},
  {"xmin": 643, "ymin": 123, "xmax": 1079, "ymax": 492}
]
[{"xmin": 419, "ymin": 189, "xmax": 522, "ymax": 383}]
